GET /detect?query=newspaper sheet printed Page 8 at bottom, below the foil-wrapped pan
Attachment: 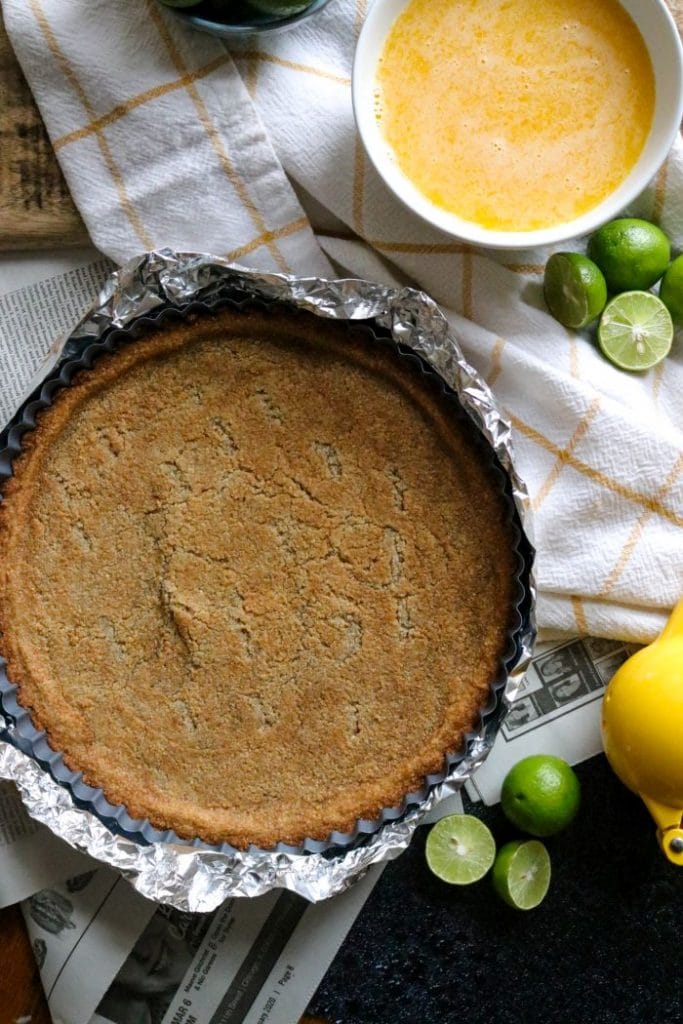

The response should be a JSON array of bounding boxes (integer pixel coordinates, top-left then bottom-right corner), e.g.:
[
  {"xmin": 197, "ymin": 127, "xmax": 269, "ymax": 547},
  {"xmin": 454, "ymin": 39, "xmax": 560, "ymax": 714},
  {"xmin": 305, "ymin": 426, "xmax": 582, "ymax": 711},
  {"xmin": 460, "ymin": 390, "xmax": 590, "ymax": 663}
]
[{"xmin": 22, "ymin": 865, "xmax": 383, "ymax": 1024}]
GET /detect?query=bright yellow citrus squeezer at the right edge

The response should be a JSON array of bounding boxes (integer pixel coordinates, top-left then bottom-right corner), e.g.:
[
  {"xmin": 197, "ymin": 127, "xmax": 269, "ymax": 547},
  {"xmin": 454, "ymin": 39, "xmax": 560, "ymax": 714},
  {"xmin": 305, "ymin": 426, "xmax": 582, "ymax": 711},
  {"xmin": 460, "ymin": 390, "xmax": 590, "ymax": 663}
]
[{"xmin": 602, "ymin": 600, "xmax": 683, "ymax": 866}]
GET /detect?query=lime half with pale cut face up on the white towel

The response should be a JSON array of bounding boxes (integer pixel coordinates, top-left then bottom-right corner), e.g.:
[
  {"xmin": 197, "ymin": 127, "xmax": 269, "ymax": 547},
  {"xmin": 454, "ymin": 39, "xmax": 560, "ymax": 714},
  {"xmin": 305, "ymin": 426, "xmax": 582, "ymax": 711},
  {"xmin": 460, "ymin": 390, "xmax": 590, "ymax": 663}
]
[{"xmin": 598, "ymin": 292, "xmax": 674, "ymax": 370}]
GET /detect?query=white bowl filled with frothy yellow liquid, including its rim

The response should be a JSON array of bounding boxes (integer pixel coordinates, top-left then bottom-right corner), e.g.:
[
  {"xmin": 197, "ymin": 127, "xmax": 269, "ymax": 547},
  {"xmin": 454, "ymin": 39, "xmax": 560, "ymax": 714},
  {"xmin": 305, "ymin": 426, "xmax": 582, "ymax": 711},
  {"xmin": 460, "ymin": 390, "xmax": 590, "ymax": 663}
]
[{"xmin": 353, "ymin": 0, "xmax": 681, "ymax": 247}]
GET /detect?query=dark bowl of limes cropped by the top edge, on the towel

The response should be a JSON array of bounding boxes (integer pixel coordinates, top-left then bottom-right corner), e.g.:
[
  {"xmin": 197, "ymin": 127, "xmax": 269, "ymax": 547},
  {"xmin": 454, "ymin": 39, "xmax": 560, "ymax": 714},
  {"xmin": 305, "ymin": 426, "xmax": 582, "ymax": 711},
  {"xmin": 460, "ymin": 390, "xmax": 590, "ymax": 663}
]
[{"xmin": 159, "ymin": 0, "xmax": 330, "ymax": 39}]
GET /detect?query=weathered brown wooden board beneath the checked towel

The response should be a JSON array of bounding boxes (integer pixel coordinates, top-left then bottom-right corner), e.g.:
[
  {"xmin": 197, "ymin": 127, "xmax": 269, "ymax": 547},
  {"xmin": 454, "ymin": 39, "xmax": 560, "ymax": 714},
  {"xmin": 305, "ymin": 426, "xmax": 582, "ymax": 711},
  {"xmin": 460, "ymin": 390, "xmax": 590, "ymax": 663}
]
[{"xmin": 0, "ymin": 0, "xmax": 683, "ymax": 250}]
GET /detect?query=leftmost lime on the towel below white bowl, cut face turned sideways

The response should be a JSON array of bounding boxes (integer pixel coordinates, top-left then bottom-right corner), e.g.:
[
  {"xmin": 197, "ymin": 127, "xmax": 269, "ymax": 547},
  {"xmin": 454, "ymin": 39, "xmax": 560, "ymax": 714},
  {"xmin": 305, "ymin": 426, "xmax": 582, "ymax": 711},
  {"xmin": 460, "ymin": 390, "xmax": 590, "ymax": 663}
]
[{"xmin": 543, "ymin": 253, "xmax": 607, "ymax": 331}]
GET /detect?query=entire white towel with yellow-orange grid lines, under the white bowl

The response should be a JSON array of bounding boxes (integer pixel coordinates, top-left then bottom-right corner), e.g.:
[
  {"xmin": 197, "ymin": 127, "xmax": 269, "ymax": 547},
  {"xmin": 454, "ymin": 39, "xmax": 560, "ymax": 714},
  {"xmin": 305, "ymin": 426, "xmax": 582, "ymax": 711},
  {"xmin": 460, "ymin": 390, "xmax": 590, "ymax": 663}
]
[{"xmin": 3, "ymin": 0, "xmax": 683, "ymax": 641}]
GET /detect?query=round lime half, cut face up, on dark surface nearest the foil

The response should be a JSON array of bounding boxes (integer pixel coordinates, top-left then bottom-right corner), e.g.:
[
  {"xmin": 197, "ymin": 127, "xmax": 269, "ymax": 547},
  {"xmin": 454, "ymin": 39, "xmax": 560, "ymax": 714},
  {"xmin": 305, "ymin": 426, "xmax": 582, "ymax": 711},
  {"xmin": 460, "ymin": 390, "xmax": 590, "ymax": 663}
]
[{"xmin": 425, "ymin": 814, "xmax": 496, "ymax": 886}]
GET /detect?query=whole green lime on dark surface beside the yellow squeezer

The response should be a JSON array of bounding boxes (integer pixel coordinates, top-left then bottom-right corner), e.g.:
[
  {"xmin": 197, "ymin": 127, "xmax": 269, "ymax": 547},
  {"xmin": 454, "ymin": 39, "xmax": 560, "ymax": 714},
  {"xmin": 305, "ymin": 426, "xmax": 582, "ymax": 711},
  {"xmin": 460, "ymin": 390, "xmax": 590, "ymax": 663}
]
[{"xmin": 501, "ymin": 754, "xmax": 581, "ymax": 836}]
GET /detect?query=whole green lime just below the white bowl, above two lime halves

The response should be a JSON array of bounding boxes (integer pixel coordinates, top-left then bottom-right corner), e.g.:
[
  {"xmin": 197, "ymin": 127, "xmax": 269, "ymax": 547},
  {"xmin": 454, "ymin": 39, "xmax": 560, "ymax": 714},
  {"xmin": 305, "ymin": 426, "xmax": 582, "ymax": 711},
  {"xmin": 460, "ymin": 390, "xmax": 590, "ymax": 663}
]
[{"xmin": 588, "ymin": 217, "xmax": 671, "ymax": 292}]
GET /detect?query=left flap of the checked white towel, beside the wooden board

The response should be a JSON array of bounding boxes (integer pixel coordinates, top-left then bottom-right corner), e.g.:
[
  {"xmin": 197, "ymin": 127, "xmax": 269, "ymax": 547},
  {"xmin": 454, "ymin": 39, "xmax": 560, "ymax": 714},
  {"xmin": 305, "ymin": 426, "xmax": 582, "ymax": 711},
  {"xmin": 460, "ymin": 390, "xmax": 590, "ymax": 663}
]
[{"xmin": 2, "ymin": 0, "xmax": 330, "ymax": 273}]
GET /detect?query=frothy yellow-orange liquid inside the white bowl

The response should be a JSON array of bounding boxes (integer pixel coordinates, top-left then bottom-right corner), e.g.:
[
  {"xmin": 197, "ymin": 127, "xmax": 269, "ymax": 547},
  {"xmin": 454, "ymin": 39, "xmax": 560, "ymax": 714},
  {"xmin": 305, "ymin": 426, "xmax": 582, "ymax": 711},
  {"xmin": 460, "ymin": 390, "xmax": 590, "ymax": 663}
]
[{"xmin": 377, "ymin": 0, "xmax": 654, "ymax": 230}]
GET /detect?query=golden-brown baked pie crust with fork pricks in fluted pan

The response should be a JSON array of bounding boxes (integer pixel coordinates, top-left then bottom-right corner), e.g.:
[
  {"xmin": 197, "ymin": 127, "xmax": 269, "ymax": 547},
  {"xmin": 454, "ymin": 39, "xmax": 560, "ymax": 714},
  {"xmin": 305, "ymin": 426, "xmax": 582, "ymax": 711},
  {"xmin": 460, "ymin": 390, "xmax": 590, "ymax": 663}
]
[{"xmin": 0, "ymin": 310, "xmax": 515, "ymax": 848}]
